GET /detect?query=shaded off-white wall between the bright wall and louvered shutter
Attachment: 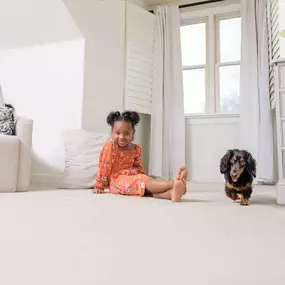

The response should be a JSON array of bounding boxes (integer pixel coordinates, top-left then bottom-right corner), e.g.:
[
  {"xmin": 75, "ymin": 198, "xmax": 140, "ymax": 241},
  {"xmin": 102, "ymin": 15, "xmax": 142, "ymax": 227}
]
[{"xmin": 64, "ymin": 0, "xmax": 125, "ymax": 132}]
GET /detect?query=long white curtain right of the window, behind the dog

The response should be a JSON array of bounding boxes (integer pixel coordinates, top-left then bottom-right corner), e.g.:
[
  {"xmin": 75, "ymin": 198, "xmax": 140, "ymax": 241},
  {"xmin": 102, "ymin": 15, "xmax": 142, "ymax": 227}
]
[{"xmin": 240, "ymin": 0, "xmax": 275, "ymax": 183}]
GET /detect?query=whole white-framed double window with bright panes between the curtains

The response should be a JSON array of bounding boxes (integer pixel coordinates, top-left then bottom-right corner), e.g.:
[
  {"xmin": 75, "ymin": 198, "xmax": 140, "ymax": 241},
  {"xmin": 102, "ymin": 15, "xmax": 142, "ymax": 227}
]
[{"xmin": 180, "ymin": 7, "xmax": 241, "ymax": 115}]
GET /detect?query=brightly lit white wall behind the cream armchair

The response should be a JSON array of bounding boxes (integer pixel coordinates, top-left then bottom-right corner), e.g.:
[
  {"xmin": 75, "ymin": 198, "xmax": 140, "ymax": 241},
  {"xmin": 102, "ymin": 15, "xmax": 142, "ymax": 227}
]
[{"xmin": 0, "ymin": 40, "xmax": 84, "ymax": 174}]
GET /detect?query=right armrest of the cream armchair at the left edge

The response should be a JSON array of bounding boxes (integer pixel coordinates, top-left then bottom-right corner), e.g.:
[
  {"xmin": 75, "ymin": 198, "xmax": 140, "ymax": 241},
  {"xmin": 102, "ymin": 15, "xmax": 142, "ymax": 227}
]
[{"xmin": 16, "ymin": 117, "xmax": 33, "ymax": 191}]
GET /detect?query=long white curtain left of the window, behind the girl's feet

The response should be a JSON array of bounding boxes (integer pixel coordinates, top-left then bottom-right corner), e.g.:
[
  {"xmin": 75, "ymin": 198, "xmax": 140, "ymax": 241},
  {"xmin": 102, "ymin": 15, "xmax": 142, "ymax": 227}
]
[{"xmin": 149, "ymin": 6, "xmax": 185, "ymax": 179}]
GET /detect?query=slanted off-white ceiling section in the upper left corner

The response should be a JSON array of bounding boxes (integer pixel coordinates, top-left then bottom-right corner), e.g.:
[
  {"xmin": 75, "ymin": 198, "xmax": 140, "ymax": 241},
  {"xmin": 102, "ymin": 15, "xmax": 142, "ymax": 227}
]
[{"xmin": 0, "ymin": 0, "xmax": 82, "ymax": 50}]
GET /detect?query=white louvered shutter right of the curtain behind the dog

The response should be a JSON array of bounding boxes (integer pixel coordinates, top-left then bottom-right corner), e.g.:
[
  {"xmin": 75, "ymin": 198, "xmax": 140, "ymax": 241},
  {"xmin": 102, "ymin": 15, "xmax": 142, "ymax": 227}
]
[{"xmin": 267, "ymin": 0, "xmax": 280, "ymax": 102}]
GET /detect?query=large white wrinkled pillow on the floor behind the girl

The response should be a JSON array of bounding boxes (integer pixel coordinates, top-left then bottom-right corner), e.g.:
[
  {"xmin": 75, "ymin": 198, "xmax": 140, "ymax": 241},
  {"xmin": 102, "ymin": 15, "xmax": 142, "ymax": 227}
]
[{"xmin": 60, "ymin": 130, "xmax": 109, "ymax": 189}]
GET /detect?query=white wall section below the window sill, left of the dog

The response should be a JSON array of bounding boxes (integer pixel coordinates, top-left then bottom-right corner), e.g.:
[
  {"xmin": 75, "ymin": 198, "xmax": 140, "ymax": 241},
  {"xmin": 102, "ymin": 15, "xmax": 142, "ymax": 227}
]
[{"xmin": 186, "ymin": 119, "xmax": 239, "ymax": 182}]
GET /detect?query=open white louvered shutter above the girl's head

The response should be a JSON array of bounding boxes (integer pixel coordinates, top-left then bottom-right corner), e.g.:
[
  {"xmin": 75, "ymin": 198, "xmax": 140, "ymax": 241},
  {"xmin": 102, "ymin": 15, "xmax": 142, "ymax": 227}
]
[{"xmin": 124, "ymin": 2, "xmax": 155, "ymax": 114}]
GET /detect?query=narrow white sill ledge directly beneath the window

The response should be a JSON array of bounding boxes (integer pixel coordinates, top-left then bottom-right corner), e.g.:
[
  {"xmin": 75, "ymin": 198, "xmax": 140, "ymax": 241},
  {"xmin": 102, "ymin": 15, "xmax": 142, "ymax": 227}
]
[{"xmin": 185, "ymin": 113, "xmax": 239, "ymax": 125}]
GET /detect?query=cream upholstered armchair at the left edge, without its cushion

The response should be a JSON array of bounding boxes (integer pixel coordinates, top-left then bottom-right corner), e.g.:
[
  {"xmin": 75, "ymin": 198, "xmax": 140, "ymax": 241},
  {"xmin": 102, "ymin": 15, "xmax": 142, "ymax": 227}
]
[{"xmin": 0, "ymin": 117, "xmax": 33, "ymax": 192}]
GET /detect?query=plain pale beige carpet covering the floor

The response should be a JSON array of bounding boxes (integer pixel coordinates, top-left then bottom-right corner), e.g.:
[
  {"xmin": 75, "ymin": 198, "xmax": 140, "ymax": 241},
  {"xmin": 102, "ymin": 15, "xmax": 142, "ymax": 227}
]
[{"xmin": 0, "ymin": 186, "xmax": 285, "ymax": 285}]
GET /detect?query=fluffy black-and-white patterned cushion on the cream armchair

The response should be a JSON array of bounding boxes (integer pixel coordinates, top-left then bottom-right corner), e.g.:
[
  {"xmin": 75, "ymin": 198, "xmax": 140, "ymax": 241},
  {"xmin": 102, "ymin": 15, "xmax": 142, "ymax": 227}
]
[{"xmin": 0, "ymin": 104, "xmax": 15, "ymax": 135}]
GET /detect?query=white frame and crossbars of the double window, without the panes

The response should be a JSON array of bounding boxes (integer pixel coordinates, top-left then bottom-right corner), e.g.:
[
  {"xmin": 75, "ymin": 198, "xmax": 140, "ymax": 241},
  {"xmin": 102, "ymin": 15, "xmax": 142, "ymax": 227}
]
[{"xmin": 180, "ymin": 3, "xmax": 240, "ymax": 118}]
